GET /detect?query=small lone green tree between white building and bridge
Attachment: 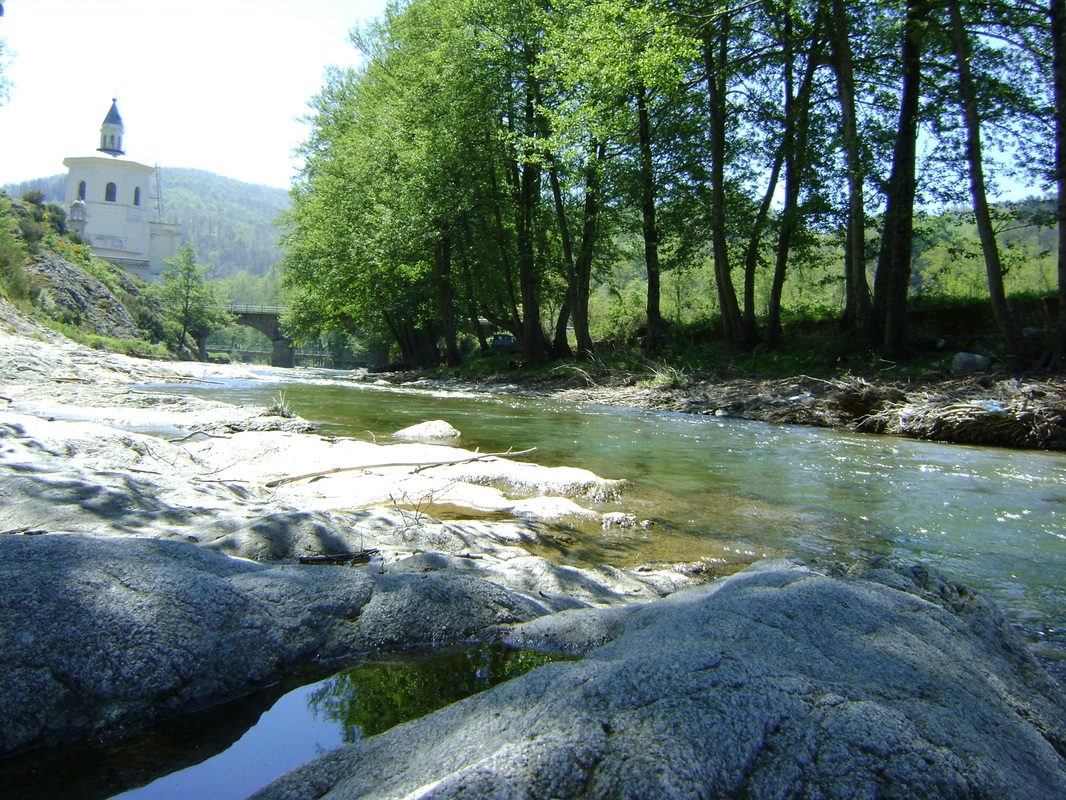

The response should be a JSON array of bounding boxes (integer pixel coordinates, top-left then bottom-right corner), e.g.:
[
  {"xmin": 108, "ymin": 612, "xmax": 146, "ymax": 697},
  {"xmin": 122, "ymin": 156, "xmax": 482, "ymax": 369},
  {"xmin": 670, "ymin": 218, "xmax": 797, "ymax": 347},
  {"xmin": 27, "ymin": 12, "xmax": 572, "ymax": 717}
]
[{"xmin": 154, "ymin": 244, "xmax": 229, "ymax": 361}]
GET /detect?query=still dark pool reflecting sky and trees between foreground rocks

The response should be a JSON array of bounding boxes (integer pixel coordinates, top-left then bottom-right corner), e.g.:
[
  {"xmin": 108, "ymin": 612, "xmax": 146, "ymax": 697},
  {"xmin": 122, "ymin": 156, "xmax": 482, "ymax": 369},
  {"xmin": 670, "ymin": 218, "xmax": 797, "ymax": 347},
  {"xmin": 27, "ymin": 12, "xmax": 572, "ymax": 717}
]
[{"xmin": 0, "ymin": 643, "xmax": 565, "ymax": 800}]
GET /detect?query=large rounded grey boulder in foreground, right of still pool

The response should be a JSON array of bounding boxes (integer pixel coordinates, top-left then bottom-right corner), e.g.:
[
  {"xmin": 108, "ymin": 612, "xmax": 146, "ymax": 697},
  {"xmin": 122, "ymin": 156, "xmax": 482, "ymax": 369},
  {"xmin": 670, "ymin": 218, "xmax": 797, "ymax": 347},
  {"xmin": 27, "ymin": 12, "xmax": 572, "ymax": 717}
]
[{"xmin": 254, "ymin": 561, "xmax": 1066, "ymax": 800}]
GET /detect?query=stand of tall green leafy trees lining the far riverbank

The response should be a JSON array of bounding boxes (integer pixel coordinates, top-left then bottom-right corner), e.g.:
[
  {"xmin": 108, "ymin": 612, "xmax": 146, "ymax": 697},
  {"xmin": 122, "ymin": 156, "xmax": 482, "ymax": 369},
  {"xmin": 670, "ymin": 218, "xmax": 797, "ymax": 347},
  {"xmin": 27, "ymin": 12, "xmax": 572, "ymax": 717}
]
[{"xmin": 284, "ymin": 0, "xmax": 1066, "ymax": 366}]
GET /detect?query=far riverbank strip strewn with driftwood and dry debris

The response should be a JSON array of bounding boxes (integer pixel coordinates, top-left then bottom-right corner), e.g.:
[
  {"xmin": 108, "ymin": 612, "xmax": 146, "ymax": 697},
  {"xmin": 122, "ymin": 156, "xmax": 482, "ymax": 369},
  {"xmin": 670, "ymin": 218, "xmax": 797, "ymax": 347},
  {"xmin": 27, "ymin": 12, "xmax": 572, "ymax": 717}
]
[{"xmin": 388, "ymin": 365, "xmax": 1066, "ymax": 450}]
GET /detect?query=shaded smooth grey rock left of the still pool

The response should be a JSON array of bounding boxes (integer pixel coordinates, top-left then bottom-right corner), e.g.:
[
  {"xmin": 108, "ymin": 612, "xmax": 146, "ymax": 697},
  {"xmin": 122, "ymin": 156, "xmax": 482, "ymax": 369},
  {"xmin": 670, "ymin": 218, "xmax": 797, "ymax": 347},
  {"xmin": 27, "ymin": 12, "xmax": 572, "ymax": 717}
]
[{"xmin": 0, "ymin": 534, "xmax": 546, "ymax": 755}]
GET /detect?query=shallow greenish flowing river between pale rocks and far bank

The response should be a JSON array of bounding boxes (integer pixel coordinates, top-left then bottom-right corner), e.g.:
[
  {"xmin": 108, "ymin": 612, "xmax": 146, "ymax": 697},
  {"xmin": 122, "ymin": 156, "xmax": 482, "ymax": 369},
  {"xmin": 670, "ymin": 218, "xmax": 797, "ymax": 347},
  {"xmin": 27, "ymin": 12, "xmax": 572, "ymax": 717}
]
[{"xmin": 174, "ymin": 370, "xmax": 1066, "ymax": 674}]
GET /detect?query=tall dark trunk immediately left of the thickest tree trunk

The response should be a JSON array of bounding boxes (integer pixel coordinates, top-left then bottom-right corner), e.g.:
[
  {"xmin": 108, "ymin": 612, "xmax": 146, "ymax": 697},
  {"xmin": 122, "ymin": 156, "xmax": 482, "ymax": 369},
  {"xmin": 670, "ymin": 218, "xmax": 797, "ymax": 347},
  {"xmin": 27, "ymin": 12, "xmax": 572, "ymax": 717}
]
[{"xmin": 830, "ymin": 0, "xmax": 875, "ymax": 341}]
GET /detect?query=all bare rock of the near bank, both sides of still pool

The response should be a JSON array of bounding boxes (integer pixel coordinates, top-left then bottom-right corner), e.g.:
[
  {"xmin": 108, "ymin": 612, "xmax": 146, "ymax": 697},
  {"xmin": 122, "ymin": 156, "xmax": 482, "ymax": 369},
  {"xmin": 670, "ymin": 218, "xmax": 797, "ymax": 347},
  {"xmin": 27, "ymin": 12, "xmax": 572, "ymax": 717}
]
[{"xmin": 6, "ymin": 302, "xmax": 1066, "ymax": 798}]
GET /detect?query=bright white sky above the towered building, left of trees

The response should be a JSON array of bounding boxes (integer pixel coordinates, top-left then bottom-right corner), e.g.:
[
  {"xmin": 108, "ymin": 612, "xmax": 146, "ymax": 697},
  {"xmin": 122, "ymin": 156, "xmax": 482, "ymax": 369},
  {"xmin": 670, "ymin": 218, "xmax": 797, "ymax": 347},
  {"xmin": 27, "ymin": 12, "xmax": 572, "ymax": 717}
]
[{"xmin": 0, "ymin": 0, "xmax": 385, "ymax": 188}]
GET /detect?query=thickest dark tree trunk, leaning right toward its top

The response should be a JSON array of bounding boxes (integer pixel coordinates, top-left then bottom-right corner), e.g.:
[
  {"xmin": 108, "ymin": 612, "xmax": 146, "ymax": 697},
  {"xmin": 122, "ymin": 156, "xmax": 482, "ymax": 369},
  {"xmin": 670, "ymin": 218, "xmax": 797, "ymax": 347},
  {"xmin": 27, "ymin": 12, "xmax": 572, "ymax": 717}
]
[{"xmin": 874, "ymin": 0, "xmax": 928, "ymax": 358}]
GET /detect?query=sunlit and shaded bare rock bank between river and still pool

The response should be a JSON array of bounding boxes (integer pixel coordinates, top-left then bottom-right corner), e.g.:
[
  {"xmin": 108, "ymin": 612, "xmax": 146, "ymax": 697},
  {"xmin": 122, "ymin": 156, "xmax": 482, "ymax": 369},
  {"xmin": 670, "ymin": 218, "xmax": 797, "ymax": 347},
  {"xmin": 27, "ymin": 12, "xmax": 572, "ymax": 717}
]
[{"xmin": 0, "ymin": 298, "xmax": 693, "ymax": 755}]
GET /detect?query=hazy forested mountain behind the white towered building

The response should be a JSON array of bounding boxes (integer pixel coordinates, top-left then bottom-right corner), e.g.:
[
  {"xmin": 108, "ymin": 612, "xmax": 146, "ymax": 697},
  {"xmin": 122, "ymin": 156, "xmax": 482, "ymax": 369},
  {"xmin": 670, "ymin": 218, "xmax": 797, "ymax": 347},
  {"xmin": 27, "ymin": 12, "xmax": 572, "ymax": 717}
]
[{"xmin": 2, "ymin": 167, "xmax": 289, "ymax": 278}]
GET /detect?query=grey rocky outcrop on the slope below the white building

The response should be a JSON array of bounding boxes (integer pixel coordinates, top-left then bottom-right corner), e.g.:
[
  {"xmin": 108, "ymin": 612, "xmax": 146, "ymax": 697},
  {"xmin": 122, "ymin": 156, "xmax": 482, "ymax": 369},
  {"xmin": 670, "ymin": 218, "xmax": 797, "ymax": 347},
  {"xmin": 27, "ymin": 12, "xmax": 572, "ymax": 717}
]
[{"xmin": 26, "ymin": 253, "xmax": 140, "ymax": 339}]
